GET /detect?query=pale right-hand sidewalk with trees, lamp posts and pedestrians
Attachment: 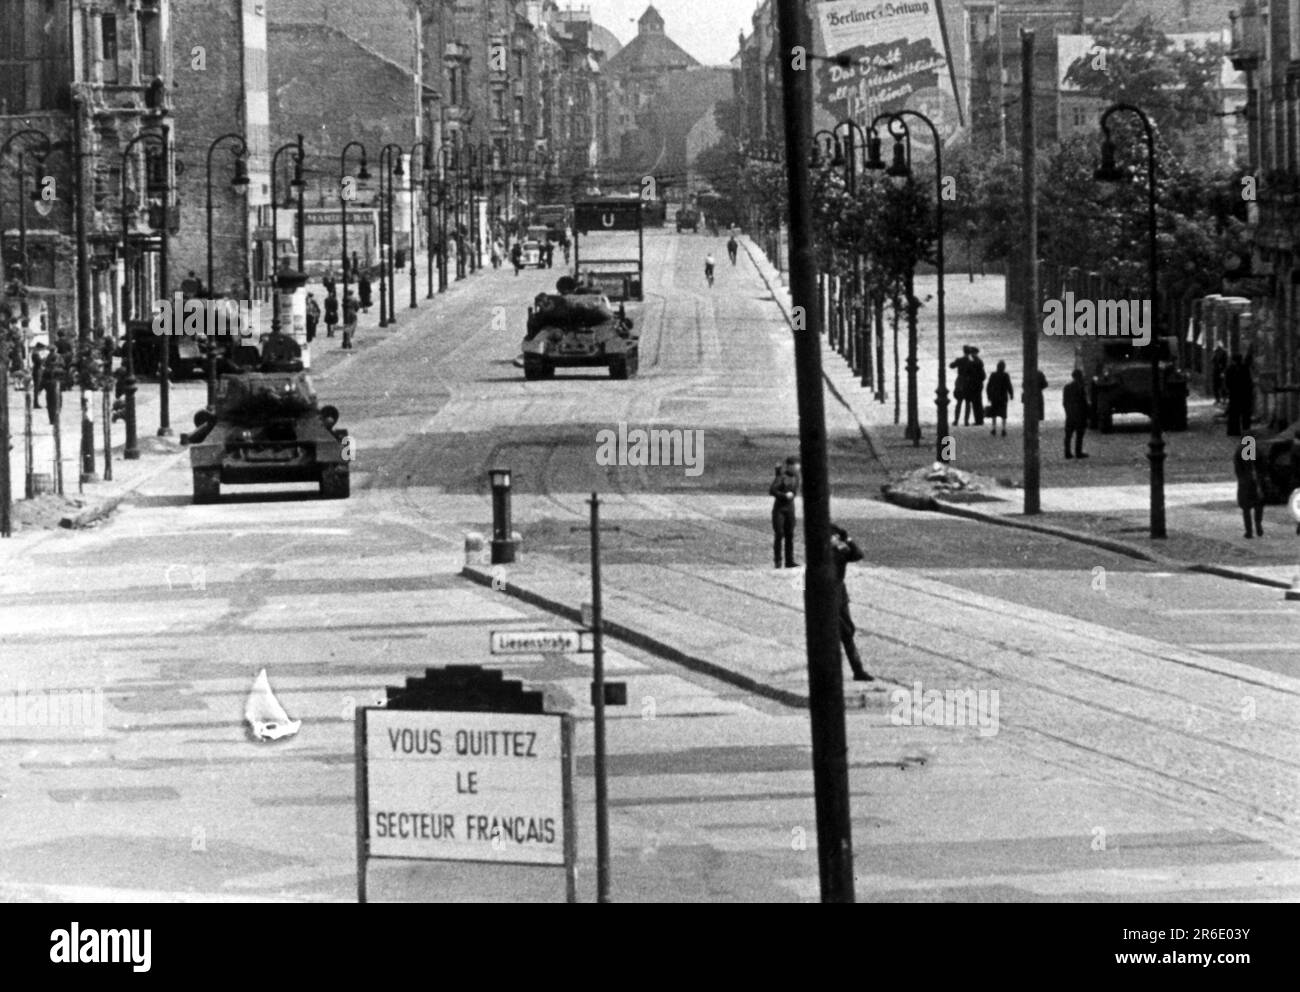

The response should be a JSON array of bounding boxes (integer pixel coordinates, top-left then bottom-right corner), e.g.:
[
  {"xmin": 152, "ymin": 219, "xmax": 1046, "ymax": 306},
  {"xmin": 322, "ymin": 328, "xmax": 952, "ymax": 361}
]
[{"xmin": 742, "ymin": 238, "xmax": 1300, "ymax": 589}]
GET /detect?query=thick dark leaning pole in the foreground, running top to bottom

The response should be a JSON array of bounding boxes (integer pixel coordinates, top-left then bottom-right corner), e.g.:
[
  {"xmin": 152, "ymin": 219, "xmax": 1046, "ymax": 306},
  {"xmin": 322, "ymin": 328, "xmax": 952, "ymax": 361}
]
[{"xmin": 776, "ymin": 0, "xmax": 854, "ymax": 902}]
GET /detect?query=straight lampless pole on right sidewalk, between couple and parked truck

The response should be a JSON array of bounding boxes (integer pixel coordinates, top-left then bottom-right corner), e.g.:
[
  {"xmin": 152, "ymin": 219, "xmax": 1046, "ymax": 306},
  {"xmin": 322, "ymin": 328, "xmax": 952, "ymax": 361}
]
[{"xmin": 1021, "ymin": 27, "xmax": 1047, "ymax": 516}]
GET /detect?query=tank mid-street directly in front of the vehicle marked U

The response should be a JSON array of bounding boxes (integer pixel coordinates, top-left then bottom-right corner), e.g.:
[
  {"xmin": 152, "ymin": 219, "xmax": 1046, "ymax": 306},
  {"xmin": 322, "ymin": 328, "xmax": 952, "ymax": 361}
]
[{"xmin": 523, "ymin": 287, "xmax": 638, "ymax": 380}]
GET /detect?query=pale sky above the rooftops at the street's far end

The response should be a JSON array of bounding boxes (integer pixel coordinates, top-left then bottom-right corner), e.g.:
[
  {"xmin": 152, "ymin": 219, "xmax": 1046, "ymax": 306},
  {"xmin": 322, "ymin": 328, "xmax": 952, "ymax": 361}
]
[{"xmin": 572, "ymin": 0, "xmax": 759, "ymax": 65}]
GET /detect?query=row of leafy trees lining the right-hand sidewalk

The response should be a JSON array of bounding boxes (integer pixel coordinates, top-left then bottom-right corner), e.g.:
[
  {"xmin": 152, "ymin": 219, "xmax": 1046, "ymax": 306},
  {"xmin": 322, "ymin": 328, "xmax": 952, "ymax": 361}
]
[{"xmin": 697, "ymin": 16, "xmax": 1253, "ymax": 314}]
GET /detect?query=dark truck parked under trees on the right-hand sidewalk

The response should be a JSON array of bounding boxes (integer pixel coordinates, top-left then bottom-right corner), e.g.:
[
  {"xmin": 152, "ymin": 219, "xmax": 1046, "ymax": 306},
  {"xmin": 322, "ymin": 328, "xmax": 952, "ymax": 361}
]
[{"xmin": 1075, "ymin": 337, "xmax": 1187, "ymax": 433}]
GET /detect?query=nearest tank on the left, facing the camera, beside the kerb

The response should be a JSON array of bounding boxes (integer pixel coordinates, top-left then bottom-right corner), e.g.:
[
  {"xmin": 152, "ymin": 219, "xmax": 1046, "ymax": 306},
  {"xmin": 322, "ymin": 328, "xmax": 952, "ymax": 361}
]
[{"xmin": 181, "ymin": 335, "xmax": 351, "ymax": 503}]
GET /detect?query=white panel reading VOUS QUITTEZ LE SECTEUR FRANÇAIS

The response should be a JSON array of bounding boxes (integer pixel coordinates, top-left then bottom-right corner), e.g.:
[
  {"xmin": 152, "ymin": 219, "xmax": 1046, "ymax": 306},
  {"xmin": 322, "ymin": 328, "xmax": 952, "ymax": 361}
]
[{"xmin": 365, "ymin": 710, "xmax": 564, "ymax": 865}]
